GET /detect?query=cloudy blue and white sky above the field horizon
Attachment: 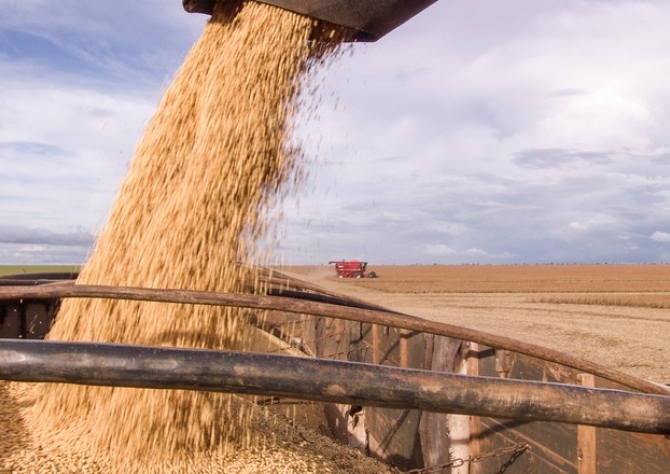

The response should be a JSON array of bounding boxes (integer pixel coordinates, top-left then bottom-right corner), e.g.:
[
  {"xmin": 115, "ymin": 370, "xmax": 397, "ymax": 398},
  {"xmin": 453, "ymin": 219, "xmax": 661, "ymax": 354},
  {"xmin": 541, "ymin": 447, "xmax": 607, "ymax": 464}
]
[{"xmin": 0, "ymin": 0, "xmax": 670, "ymax": 264}]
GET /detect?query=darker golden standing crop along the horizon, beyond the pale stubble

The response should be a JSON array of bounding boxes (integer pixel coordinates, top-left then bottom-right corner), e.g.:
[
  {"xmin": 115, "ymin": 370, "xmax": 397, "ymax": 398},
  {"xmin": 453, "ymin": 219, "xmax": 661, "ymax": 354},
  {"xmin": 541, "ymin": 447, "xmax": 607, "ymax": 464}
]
[{"xmin": 285, "ymin": 265, "xmax": 670, "ymax": 308}]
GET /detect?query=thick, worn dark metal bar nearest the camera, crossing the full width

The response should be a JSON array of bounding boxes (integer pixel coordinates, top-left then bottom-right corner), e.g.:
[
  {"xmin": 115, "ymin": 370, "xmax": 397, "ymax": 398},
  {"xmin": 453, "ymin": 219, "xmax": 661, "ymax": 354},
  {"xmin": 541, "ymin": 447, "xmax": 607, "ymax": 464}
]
[{"xmin": 0, "ymin": 340, "xmax": 670, "ymax": 434}]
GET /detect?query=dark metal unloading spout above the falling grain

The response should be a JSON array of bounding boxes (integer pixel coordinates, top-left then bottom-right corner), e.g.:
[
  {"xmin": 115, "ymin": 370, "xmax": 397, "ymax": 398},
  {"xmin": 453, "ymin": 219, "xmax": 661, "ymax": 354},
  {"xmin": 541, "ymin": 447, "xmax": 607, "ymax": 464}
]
[{"xmin": 182, "ymin": 0, "xmax": 437, "ymax": 42}]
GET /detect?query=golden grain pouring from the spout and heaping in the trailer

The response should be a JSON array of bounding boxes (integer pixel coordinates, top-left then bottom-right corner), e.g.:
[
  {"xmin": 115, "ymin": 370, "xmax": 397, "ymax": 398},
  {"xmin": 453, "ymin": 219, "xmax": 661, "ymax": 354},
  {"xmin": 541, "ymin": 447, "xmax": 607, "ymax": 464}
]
[{"xmin": 1, "ymin": 1, "xmax": 394, "ymax": 472}]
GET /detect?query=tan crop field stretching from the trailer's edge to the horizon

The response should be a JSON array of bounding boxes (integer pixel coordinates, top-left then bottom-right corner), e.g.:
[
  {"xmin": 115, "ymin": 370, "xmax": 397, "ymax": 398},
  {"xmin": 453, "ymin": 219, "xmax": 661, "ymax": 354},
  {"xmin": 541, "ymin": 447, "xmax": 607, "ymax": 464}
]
[{"xmin": 283, "ymin": 265, "xmax": 670, "ymax": 384}]
